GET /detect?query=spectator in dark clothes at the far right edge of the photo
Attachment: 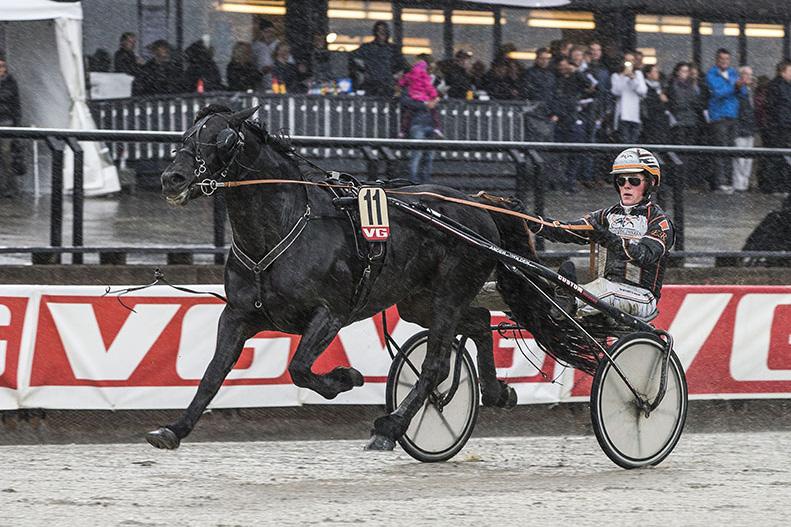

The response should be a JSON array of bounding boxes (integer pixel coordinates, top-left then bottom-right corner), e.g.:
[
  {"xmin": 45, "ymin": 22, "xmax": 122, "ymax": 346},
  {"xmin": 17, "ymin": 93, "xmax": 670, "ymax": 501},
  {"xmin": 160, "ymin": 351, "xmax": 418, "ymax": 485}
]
[{"xmin": 764, "ymin": 59, "xmax": 791, "ymax": 193}]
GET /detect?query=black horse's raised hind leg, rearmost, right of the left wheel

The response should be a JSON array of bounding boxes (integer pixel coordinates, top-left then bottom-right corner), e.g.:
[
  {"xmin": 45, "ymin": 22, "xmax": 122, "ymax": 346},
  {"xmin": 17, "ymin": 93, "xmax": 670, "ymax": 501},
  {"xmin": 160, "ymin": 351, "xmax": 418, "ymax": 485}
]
[{"xmin": 456, "ymin": 307, "xmax": 516, "ymax": 408}]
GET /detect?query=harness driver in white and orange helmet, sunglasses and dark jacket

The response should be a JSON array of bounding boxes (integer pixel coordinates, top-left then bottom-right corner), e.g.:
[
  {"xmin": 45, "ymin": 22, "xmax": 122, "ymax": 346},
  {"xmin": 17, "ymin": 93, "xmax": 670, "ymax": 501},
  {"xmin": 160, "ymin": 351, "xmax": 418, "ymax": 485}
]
[{"xmin": 529, "ymin": 148, "xmax": 675, "ymax": 321}]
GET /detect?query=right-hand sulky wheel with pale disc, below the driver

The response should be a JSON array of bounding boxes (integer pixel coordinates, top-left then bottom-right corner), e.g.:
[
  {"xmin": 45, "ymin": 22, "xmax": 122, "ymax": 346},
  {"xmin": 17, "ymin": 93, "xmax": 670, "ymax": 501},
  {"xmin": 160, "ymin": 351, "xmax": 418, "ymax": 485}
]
[{"xmin": 591, "ymin": 333, "xmax": 687, "ymax": 468}]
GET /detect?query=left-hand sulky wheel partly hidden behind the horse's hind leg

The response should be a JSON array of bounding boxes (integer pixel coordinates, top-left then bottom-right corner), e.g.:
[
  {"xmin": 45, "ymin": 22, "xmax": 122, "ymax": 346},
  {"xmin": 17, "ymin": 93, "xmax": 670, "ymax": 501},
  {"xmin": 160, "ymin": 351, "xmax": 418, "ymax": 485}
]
[{"xmin": 385, "ymin": 331, "xmax": 480, "ymax": 463}]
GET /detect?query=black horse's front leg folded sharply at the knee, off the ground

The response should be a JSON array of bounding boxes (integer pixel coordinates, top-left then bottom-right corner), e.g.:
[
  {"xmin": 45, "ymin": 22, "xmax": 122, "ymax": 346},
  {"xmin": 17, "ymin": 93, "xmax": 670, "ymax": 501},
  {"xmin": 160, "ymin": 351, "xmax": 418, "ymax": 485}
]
[{"xmin": 288, "ymin": 307, "xmax": 364, "ymax": 399}]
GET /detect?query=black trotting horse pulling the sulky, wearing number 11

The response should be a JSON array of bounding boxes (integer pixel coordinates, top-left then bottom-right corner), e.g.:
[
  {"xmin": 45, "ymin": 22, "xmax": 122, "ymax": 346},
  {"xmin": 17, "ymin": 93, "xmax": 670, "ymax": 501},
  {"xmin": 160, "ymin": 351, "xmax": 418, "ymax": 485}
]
[{"xmin": 146, "ymin": 105, "xmax": 516, "ymax": 450}]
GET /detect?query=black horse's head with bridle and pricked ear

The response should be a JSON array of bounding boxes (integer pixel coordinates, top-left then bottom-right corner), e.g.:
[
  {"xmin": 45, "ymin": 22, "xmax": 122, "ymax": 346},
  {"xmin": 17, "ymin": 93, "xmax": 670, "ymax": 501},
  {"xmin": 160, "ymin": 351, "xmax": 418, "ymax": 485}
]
[{"xmin": 161, "ymin": 104, "xmax": 258, "ymax": 205}]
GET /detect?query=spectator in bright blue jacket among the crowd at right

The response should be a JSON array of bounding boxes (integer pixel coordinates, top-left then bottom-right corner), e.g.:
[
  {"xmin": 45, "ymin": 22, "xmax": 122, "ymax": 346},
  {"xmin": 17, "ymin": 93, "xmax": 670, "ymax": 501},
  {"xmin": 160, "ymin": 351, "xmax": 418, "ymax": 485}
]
[{"xmin": 706, "ymin": 48, "xmax": 746, "ymax": 194}]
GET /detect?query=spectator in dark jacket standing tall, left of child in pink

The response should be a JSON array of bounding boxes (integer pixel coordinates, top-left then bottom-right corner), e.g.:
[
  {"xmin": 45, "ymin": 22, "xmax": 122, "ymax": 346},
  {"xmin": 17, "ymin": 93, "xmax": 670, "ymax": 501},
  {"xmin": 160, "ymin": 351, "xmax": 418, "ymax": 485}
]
[{"xmin": 352, "ymin": 20, "xmax": 409, "ymax": 97}]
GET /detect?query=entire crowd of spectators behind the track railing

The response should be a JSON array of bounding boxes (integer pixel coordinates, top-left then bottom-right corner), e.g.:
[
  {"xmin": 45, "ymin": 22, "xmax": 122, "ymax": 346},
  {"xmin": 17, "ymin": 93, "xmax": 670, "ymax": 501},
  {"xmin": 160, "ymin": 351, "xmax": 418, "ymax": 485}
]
[{"xmin": 0, "ymin": 19, "xmax": 791, "ymax": 193}]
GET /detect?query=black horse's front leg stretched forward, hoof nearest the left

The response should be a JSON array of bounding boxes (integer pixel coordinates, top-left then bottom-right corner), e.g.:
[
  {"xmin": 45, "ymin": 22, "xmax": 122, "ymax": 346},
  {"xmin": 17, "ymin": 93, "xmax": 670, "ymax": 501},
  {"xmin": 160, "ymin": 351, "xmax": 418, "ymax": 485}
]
[{"xmin": 146, "ymin": 305, "xmax": 262, "ymax": 449}]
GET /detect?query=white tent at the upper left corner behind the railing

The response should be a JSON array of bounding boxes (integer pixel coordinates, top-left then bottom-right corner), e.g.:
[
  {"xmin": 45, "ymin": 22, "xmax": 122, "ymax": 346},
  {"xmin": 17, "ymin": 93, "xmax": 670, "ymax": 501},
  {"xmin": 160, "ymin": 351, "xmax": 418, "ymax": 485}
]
[{"xmin": 0, "ymin": 0, "xmax": 120, "ymax": 196}]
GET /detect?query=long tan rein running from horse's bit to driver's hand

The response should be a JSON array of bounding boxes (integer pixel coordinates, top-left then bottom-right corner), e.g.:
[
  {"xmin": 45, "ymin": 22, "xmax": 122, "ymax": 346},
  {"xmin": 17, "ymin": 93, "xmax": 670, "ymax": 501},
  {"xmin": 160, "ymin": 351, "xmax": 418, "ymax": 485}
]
[{"xmin": 196, "ymin": 178, "xmax": 593, "ymax": 231}]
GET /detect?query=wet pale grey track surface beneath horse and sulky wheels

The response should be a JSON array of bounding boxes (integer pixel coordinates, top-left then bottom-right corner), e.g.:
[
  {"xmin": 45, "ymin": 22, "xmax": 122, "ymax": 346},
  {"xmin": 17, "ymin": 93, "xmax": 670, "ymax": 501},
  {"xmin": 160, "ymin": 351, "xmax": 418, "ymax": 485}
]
[{"xmin": 0, "ymin": 432, "xmax": 791, "ymax": 527}]
